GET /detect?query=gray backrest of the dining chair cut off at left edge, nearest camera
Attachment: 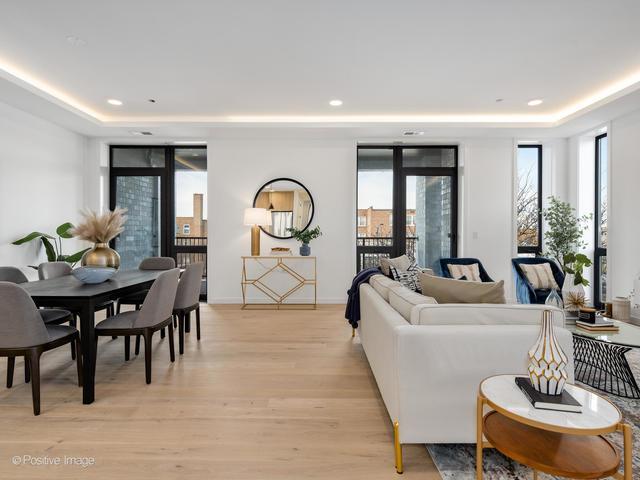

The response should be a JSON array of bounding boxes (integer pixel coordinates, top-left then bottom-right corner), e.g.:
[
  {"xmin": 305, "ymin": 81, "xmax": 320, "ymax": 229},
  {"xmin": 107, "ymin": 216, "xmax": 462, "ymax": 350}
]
[{"xmin": 0, "ymin": 282, "xmax": 49, "ymax": 348}]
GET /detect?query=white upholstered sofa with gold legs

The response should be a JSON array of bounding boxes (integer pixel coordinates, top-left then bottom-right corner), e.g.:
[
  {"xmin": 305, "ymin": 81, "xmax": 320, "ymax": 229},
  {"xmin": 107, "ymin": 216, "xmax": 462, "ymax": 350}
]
[{"xmin": 358, "ymin": 275, "xmax": 573, "ymax": 472}]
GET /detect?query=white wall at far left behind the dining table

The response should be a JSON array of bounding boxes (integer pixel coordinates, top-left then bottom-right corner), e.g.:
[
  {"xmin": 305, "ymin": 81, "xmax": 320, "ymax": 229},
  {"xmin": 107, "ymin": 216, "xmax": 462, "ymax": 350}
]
[{"xmin": 0, "ymin": 103, "xmax": 85, "ymax": 274}]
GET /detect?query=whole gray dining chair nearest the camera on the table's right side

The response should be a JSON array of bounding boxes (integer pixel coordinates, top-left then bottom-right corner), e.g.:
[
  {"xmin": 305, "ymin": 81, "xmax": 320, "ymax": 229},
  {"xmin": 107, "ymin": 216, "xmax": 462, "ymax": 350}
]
[{"xmin": 95, "ymin": 268, "xmax": 180, "ymax": 383}]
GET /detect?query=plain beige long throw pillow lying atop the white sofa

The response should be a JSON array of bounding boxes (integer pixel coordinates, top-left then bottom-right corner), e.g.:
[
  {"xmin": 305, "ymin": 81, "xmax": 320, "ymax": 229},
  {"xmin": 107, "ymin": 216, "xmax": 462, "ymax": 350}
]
[{"xmin": 420, "ymin": 274, "xmax": 506, "ymax": 303}]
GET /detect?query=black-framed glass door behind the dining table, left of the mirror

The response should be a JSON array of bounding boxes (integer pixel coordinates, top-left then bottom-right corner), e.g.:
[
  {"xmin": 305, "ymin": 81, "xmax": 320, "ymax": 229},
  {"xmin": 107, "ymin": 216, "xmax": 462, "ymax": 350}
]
[{"xmin": 110, "ymin": 145, "xmax": 208, "ymax": 297}]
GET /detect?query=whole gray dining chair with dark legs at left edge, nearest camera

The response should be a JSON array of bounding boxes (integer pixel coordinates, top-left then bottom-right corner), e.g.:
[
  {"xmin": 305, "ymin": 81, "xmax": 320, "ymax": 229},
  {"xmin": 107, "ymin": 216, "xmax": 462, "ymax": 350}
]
[{"xmin": 0, "ymin": 282, "xmax": 82, "ymax": 415}]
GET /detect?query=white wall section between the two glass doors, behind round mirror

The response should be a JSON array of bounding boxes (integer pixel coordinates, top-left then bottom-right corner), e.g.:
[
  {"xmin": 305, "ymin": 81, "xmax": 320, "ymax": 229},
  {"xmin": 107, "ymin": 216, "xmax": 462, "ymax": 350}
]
[{"xmin": 207, "ymin": 139, "xmax": 356, "ymax": 303}]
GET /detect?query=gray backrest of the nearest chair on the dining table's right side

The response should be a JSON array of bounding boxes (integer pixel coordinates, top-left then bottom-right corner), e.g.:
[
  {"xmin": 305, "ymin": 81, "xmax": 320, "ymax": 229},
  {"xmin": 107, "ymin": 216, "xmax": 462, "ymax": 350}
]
[{"xmin": 135, "ymin": 268, "xmax": 180, "ymax": 327}]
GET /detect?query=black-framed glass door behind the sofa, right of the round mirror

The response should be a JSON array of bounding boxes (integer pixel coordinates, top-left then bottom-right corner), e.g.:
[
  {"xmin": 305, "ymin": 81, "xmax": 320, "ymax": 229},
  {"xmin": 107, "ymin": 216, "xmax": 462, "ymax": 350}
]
[{"xmin": 356, "ymin": 146, "xmax": 457, "ymax": 270}]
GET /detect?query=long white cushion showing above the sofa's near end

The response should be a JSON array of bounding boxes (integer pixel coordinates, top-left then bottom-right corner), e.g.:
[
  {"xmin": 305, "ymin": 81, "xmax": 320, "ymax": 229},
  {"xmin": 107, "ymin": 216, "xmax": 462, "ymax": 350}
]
[{"xmin": 409, "ymin": 303, "xmax": 565, "ymax": 327}]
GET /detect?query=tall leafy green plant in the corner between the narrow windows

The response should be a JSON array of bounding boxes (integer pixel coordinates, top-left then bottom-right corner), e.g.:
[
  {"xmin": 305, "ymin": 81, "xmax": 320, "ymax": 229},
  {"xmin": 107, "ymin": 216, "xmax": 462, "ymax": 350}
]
[{"xmin": 542, "ymin": 197, "xmax": 592, "ymax": 286}]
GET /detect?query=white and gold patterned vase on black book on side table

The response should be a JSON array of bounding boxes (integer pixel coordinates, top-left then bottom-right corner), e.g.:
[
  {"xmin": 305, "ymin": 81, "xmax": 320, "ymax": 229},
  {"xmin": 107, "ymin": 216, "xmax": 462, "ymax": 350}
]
[{"xmin": 528, "ymin": 310, "xmax": 568, "ymax": 395}]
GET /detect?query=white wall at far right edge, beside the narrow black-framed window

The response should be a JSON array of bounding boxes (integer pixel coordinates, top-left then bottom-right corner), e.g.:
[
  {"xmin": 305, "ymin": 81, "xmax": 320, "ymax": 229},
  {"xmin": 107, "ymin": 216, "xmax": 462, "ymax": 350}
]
[{"xmin": 607, "ymin": 111, "xmax": 640, "ymax": 301}]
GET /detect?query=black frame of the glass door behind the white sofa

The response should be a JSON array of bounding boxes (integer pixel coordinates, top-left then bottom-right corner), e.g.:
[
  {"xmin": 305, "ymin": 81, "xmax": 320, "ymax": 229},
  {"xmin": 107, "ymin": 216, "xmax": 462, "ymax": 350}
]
[{"xmin": 355, "ymin": 144, "xmax": 459, "ymax": 272}]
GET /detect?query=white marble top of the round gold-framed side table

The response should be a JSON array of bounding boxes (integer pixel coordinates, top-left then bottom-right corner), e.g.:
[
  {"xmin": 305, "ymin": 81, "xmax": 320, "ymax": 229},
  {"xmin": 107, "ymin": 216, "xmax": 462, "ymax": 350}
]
[{"xmin": 480, "ymin": 375, "xmax": 622, "ymax": 433}]
